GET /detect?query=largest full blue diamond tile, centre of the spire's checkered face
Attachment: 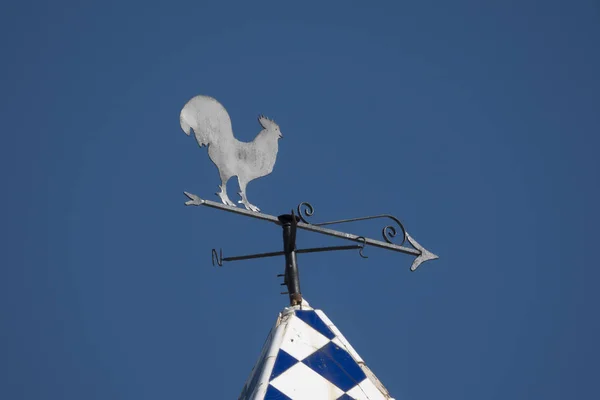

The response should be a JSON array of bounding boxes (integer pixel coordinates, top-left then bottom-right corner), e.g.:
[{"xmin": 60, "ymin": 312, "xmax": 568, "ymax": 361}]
[{"xmin": 302, "ymin": 342, "xmax": 366, "ymax": 392}]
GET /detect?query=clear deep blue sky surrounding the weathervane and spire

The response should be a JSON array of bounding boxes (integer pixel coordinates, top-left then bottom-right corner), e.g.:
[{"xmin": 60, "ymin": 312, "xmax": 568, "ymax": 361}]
[{"xmin": 0, "ymin": 0, "xmax": 600, "ymax": 400}]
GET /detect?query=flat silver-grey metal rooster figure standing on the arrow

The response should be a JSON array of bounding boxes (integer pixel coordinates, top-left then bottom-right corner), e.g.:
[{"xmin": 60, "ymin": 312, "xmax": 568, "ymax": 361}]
[{"xmin": 179, "ymin": 96, "xmax": 283, "ymax": 212}]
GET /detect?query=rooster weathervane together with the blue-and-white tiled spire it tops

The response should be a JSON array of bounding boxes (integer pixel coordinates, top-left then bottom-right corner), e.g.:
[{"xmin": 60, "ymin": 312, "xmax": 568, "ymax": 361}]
[{"xmin": 180, "ymin": 96, "xmax": 438, "ymax": 400}]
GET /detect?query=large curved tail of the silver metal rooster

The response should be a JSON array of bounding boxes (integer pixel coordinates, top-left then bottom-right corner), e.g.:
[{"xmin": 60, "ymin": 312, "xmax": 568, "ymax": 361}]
[{"xmin": 179, "ymin": 96, "xmax": 233, "ymax": 146}]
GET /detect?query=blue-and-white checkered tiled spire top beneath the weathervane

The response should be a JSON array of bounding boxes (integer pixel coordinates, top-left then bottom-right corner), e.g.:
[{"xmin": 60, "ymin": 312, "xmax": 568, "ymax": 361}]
[{"xmin": 239, "ymin": 300, "xmax": 393, "ymax": 400}]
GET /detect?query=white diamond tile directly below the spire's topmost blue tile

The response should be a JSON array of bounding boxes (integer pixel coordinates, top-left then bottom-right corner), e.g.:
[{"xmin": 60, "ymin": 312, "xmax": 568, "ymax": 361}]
[{"xmin": 281, "ymin": 316, "xmax": 329, "ymax": 360}]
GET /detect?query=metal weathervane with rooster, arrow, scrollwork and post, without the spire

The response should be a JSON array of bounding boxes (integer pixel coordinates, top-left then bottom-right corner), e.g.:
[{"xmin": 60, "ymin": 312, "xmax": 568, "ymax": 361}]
[{"xmin": 180, "ymin": 96, "xmax": 438, "ymax": 305}]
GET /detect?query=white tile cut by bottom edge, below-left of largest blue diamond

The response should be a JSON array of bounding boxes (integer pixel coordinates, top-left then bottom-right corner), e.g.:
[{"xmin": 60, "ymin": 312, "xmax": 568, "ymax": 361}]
[{"xmin": 271, "ymin": 363, "xmax": 344, "ymax": 400}]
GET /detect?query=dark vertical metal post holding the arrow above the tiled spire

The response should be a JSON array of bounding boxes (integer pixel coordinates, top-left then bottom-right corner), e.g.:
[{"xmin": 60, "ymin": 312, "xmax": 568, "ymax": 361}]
[{"xmin": 278, "ymin": 212, "xmax": 302, "ymax": 306}]
